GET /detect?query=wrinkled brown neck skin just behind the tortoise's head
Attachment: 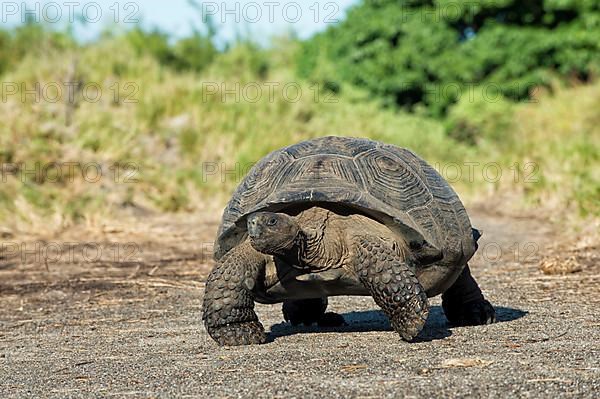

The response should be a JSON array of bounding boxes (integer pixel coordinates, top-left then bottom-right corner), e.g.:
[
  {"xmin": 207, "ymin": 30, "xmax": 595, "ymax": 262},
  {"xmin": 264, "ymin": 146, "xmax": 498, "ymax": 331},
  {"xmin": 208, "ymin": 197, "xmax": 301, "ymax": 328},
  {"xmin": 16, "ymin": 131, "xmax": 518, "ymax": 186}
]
[{"xmin": 283, "ymin": 221, "xmax": 347, "ymax": 271}]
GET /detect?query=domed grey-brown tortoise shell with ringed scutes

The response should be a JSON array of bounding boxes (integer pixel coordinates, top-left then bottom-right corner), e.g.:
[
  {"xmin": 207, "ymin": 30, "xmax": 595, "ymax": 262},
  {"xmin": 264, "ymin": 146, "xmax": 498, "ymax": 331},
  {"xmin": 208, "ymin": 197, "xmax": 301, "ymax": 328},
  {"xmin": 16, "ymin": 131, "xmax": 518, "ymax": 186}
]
[{"xmin": 214, "ymin": 136, "xmax": 476, "ymax": 267}]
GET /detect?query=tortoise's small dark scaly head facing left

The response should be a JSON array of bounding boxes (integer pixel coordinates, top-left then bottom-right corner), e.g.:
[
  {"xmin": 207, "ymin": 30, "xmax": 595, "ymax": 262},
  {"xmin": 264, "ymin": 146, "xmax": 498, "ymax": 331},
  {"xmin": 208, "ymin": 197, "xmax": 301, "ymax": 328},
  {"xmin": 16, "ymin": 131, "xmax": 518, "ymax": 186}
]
[{"xmin": 246, "ymin": 212, "xmax": 301, "ymax": 255}]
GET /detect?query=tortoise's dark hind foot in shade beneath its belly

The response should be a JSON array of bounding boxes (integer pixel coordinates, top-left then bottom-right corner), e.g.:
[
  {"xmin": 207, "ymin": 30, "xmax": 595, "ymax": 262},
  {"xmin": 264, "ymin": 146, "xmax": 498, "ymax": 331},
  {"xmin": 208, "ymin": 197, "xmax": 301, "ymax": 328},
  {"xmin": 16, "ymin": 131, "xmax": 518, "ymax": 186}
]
[{"xmin": 281, "ymin": 297, "xmax": 346, "ymax": 327}]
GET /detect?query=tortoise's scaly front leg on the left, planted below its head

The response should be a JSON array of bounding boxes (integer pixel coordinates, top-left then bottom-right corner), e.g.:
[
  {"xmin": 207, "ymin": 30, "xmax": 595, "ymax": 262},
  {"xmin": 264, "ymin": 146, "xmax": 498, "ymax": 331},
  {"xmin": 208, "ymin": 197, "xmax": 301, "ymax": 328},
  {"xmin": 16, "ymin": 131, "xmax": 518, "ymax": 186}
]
[{"xmin": 202, "ymin": 242, "xmax": 266, "ymax": 345}]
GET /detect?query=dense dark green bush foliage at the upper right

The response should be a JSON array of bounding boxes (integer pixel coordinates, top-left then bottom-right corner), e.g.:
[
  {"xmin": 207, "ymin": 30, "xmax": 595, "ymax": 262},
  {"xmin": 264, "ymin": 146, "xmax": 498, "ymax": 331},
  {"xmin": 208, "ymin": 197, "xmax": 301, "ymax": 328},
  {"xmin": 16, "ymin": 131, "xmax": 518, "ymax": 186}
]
[{"xmin": 299, "ymin": 0, "xmax": 600, "ymax": 116}]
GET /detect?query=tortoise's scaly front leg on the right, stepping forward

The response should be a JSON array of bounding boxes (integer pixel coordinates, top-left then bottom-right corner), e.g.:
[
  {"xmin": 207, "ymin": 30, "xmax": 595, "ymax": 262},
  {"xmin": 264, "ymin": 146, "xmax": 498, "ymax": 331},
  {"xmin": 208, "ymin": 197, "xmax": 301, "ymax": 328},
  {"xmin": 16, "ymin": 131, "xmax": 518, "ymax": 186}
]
[{"xmin": 355, "ymin": 237, "xmax": 429, "ymax": 341}]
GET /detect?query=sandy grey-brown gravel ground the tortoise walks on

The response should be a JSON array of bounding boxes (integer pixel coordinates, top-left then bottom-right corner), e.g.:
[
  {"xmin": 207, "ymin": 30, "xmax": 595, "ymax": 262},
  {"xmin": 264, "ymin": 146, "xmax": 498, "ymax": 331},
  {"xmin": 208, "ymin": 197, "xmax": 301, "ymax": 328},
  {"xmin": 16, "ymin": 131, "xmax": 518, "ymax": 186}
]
[{"xmin": 0, "ymin": 209, "xmax": 600, "ymax": 398}]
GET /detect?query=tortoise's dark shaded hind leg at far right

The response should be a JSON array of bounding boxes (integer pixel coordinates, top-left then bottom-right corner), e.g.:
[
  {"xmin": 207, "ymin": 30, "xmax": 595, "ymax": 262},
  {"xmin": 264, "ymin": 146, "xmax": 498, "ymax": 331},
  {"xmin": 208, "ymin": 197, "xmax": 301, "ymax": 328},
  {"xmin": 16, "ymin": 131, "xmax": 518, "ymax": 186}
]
[{"xmin": 442, "ymin": 265, "xmax": 496, "ymax": 326}]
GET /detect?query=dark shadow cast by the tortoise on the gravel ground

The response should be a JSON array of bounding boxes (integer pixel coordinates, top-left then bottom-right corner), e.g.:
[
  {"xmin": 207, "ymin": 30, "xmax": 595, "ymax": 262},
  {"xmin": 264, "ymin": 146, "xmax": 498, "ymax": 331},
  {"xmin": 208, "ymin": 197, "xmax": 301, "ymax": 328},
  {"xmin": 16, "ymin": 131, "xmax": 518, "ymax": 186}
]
[{"xmin": 269, "ymin": 306, "xmax": 528, "ymax": 342}]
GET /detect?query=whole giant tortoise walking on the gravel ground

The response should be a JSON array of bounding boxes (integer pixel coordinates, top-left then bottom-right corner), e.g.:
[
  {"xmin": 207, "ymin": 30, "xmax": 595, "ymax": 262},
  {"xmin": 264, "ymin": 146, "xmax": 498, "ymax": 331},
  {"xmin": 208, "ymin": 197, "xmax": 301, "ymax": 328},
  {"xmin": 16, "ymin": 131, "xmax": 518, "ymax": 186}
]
[{"xmin": 203, "ymin": 137, "xmax": 495, "ymax": 345}]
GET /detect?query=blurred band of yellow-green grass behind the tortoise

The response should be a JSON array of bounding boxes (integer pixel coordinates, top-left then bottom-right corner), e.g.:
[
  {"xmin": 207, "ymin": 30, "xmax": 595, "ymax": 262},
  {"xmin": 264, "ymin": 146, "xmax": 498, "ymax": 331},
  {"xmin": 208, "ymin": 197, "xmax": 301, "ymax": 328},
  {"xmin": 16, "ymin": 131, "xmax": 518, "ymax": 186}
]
[{"xmin": 0, "ymin": 37, "xmax": 600, "ymax": 228}]
